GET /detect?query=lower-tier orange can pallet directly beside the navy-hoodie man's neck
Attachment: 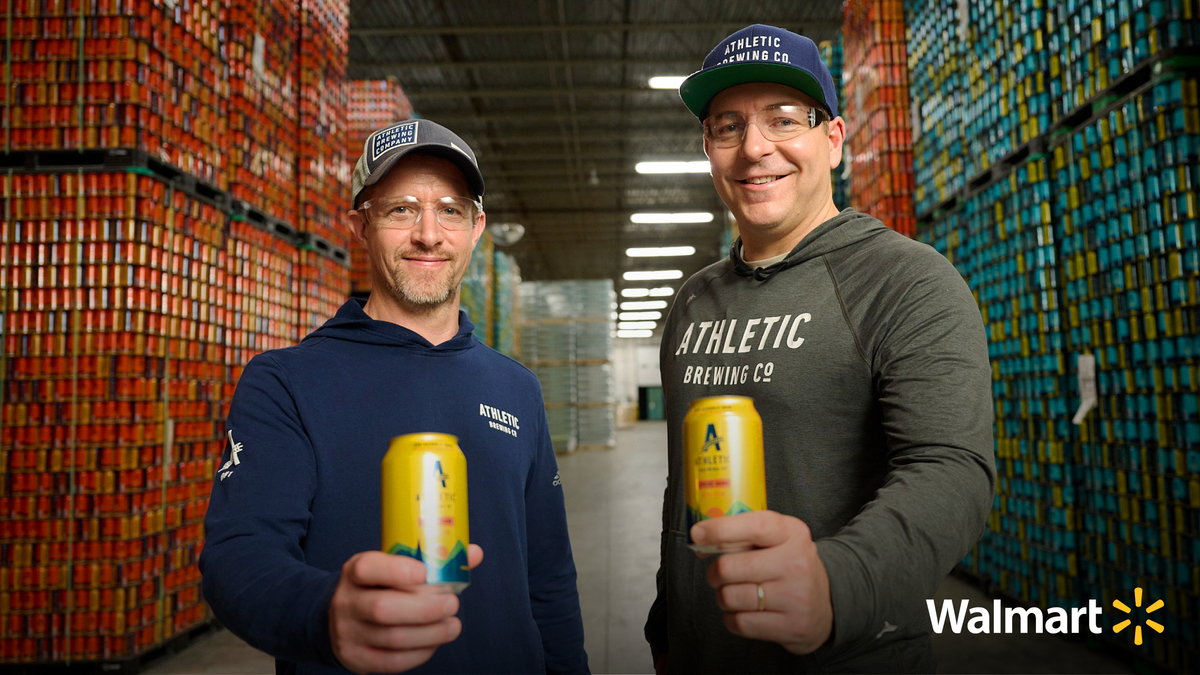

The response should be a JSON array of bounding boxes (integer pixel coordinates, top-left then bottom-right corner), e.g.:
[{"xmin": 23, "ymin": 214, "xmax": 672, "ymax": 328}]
[{"xmin": 295, "ymin": 232, "xmax": 350, "ymax": 339}]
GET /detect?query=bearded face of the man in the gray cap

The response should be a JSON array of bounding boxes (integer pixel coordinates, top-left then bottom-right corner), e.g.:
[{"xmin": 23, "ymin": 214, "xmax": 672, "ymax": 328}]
[{"xmin": 350, "ymin": 155, "xmax": 485, "ymax": 313}]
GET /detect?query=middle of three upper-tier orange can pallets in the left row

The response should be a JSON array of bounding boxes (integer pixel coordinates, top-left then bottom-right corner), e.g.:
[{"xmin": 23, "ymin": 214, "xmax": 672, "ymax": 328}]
[{"xmin": 227, "ymin": 0, "xmax": 300, "ymax": 225}]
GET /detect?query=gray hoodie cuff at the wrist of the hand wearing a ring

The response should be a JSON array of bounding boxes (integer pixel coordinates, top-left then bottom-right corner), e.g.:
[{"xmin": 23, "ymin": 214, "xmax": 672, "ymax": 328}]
[{"xmin": 816, "ymin": 539, "xmax": 875, "ymax": 649}]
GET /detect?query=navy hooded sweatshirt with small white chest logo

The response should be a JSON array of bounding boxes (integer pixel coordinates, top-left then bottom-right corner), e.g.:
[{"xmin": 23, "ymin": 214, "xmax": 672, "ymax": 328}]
[{"xmin": 200, "ymin": 299, "xmax": 587, "ymax": 673}]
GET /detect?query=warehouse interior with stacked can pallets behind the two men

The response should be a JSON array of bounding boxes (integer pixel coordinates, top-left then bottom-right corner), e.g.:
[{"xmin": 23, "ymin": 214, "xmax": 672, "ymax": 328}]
[{"xmin": 0, "ymin": 0, "xmax": 1200, "ymax": 674}]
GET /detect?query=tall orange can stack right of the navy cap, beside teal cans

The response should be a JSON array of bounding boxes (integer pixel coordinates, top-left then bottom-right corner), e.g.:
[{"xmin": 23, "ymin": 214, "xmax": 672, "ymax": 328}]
[{"xmin": 842, "ymin": 0, "xmax": 916, "ymax": 237}]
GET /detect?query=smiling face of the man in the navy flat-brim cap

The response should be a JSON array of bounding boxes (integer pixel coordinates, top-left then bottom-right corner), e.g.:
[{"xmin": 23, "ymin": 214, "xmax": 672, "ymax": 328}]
[{"xmin": 704, "ymin": 82, "xmax": 845, "ymax": 252}]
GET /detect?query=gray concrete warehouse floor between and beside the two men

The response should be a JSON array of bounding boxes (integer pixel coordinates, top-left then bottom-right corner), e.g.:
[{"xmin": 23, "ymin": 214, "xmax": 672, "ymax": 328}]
[{"xmin": 145, "ymin": 422, "xmax": 1134, "ymax": 675}]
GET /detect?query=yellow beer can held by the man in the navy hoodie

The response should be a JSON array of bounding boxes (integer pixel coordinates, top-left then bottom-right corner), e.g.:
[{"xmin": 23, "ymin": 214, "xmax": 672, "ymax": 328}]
[{"xmin": 383, "ymin": 434, "xmax": 470, "ymax": 593}]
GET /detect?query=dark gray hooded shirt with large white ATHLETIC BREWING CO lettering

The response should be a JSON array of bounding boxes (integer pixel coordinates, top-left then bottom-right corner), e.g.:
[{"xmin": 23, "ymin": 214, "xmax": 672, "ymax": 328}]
[{"xmin": 646, "ymin": 209, "xmax": 995, "ymax": 673}]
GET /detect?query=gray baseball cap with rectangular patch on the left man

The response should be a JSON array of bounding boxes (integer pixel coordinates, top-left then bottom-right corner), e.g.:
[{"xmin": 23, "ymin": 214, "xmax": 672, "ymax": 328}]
[{"xmin": 350, "ymin": 119, "xmax": 484, "ymax": 203}]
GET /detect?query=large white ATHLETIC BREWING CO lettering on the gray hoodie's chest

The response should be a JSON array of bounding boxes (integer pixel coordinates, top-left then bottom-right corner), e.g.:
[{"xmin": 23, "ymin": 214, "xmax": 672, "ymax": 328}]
[{"xmin": 674, "ymin": 312, "xmax": 812, "ymax": 386}]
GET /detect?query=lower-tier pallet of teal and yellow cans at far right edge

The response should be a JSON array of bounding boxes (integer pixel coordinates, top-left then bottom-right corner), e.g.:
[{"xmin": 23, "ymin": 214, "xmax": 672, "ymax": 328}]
[{"xmin": 1054, "ymin": 73, "xmax": 1200, "ymax": 671}]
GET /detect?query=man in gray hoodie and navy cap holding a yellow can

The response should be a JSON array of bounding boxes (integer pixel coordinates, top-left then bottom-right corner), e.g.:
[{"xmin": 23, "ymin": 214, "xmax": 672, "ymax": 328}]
[{"xmin": 646, "ymin": 25, "xmax": 995, "ymax": 673}]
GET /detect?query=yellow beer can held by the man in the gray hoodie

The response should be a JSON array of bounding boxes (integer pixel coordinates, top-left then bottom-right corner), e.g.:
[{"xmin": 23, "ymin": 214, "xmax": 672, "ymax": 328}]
[{"xmin": 683, "ymin": 396, "xmax": 767, "ymax": 554}]
